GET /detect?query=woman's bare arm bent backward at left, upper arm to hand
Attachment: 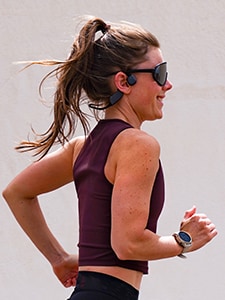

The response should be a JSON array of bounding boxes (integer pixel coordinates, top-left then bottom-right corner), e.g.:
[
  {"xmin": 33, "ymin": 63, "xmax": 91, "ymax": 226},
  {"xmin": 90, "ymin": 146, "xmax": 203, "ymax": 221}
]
[{"xmin": 3, "ymin": 139, "xmax": 84, "ymax": 286}]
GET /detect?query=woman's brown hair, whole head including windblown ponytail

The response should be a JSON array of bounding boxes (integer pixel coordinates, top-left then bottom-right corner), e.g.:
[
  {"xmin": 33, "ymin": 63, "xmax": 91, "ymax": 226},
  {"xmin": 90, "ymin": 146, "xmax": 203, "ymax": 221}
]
[{"xmin": 16, "ymin": 18, "xmax": 160, "ymax": 157}]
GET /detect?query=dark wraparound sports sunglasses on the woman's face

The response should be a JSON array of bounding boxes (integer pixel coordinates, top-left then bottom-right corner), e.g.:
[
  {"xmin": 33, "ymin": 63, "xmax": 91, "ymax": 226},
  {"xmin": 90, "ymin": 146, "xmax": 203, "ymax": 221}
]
[{"xmin": 126, "ymin": 62, "xmax": 168, "ymax": 86}]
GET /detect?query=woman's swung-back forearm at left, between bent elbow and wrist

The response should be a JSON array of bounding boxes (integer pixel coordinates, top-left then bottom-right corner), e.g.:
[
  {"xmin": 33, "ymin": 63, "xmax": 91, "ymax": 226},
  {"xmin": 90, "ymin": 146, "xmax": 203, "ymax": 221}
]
[{"xmin": 3, "ymin": 192, "xmax": 67, "ymax": 266}]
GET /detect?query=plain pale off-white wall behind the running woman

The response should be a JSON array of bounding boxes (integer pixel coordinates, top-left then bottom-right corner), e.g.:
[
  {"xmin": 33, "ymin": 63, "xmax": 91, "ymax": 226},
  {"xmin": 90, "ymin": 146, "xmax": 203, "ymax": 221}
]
[{"xmin": 0, "ymin": 0, "xmax": 225, "ymax": 300}]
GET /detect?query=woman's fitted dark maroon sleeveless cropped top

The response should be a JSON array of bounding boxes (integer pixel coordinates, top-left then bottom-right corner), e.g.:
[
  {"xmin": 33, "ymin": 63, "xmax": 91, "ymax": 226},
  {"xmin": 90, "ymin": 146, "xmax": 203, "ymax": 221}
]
[{"xmin": 73, "ymin": 119, "xmax": 164, "ymax": 274}]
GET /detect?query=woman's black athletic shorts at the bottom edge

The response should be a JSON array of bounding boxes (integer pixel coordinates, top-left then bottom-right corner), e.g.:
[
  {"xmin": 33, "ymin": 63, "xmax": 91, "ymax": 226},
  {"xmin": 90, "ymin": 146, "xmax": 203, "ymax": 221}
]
[{"xmin": 68, "ymin": 271, "xmax": 139, "ymax": 300}]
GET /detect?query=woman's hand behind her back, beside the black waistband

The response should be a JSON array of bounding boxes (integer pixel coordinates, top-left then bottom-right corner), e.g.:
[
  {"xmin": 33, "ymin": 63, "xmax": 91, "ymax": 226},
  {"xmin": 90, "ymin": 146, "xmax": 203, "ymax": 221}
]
[{"xmin": 52, "ymin": 255, "xmax": 78, "ymax": 288}]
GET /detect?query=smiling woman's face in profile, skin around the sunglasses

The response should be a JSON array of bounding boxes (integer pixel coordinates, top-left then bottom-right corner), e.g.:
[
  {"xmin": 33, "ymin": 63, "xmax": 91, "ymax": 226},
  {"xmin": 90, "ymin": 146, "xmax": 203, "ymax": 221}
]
[{"xmin": 129, "ymin": 48, "xmax": 172, "ymax": 123}]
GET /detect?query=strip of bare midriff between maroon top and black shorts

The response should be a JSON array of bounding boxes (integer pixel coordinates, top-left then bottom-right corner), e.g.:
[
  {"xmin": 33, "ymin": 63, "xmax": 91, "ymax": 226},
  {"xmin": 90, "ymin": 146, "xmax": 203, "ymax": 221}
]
[{"xmin": 79, "ymin": 266, "xmax": 143, "ymax": 290}]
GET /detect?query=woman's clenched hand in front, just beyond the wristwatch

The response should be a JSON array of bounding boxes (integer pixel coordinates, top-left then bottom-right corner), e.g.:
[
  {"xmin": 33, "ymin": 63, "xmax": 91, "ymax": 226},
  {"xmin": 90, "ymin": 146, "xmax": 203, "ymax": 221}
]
[{"xmin": 180, "ymin": 206, "xmax": 217, "ymax": 252}]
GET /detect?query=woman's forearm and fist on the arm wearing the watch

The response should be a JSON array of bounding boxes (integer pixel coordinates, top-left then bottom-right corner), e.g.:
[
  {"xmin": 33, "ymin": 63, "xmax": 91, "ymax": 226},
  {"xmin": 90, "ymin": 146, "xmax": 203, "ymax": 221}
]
[{"xmin": 112, "ymin": 207, "xmax": 217, "ymax": 260}]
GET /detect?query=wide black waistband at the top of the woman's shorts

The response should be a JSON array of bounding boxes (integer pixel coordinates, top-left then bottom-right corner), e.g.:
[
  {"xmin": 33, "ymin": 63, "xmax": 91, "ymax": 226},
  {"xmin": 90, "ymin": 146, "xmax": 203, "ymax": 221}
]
[{"xmin": 75, "ymin": 271, "xmax": 139, "ymax": 300}]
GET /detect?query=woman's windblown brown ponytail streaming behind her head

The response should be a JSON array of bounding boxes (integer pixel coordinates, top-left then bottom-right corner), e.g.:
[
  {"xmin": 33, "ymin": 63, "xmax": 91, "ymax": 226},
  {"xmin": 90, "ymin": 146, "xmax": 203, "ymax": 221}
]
[{"xmin": 16, "ymin": 19, "xmax": 109, "ymax": 159}]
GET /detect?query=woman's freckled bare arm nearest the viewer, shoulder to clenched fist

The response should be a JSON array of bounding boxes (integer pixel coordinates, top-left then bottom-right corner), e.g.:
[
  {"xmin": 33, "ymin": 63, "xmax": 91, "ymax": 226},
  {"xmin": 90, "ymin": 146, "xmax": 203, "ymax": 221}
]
[{"xmin": 109, "ymin": 130, "xmax": 217, "ymax": 260}]
